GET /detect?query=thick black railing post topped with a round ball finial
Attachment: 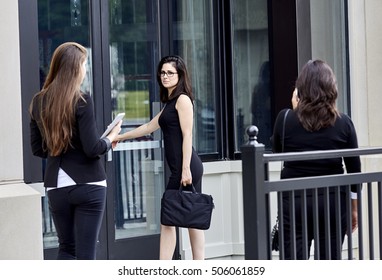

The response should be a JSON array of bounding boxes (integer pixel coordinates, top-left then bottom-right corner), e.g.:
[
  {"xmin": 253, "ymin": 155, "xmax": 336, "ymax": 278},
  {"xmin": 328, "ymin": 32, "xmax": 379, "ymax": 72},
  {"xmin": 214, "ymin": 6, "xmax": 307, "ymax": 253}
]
[{"xmin": 241, "ymin": 126, "xmax": 270, "ymax": 260}]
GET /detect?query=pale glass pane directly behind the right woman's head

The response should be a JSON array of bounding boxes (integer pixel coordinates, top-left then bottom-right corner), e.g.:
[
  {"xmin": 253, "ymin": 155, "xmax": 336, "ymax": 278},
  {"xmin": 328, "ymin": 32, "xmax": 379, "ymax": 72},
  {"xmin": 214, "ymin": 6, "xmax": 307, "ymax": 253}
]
[{"xmin": 310, "ymin": 0, "xmax": 349, "ymax": 113}]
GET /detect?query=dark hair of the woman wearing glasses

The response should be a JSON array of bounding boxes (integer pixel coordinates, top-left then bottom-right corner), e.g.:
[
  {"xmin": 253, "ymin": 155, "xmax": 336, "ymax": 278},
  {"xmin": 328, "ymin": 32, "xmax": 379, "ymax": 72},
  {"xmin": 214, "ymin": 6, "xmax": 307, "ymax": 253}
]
[{"xmin": 157, "ymin": 55, "xmax": 194, "ymax": 103}]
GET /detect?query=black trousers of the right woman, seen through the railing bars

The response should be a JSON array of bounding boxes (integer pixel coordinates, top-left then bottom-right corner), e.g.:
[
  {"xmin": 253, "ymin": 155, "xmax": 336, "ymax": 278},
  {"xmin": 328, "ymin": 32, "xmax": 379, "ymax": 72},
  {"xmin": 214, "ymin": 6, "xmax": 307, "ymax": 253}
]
[{"xmin": 283, "ymin": 192, "xmax": 347, "ymax": 260}]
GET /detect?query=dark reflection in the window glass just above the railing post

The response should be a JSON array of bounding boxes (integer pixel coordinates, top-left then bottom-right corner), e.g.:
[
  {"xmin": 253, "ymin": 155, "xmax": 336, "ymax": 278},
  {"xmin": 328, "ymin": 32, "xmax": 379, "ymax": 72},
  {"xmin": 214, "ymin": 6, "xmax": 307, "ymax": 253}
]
[{"xmin": 251, "ymin": 61, "xmax": 271, "ymax": 145}]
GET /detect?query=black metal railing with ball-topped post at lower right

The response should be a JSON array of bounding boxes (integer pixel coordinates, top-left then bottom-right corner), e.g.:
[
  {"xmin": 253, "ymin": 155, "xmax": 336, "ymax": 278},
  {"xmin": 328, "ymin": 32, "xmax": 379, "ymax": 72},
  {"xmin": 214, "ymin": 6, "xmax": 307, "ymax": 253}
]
[{"xmin": 241, "ymin": 126, "xmax": 382, "ymax": 259}]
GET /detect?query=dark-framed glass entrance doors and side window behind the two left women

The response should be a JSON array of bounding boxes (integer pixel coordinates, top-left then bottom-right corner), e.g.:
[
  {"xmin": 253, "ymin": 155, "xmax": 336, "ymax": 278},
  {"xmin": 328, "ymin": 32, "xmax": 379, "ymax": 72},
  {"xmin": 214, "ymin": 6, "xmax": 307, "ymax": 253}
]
[{"xmin": 18, "ymin": 0, "xmax": 218, "ymax": 259}]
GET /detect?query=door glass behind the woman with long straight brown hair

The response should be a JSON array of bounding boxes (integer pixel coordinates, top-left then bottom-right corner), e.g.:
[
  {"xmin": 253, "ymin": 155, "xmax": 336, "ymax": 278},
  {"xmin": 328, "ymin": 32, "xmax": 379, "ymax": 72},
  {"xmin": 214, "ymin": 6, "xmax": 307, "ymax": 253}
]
[{"xmin": 38, "ymin": 0, "xmax": 93, "ymax": 249}]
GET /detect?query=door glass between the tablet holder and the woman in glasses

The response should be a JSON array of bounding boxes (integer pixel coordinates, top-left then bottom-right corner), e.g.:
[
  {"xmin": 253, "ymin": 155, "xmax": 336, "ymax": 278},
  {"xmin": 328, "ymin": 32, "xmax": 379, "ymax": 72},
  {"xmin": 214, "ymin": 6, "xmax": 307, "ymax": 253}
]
[{"xmin": 109, "ymin": 0, "xmax": 164, "ymax": 239}]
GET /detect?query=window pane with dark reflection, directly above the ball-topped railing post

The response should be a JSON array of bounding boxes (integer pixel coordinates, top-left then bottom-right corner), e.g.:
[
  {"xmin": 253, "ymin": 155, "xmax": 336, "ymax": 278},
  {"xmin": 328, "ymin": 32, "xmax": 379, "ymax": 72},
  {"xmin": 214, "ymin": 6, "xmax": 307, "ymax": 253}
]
[{"xmin": 231, "ymin": 0, "xmax": 272, "ymax": 152}]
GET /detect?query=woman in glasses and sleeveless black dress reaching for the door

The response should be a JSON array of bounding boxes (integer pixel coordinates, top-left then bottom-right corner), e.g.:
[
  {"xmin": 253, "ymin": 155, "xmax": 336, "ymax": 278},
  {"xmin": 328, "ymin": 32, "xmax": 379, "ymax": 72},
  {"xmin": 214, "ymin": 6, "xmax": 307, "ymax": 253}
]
[{"xmin": 117, "ymin": 56, "xmax": 204, "ymax": 259}]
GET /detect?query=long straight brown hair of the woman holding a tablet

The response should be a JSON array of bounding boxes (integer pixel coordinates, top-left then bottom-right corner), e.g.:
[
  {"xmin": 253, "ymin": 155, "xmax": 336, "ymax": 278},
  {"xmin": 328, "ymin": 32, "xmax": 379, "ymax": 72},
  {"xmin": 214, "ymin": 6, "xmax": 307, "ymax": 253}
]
[{"xmin": 29, "ymin": 42, "xmax": 87, "ymax": 156}]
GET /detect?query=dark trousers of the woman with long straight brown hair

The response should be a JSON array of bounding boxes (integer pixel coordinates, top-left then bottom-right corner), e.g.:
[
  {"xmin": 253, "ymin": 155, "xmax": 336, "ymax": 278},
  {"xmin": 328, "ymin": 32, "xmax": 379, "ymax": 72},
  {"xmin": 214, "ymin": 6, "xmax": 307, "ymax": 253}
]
[{"xmin": 48, "ymin": 184, "xmax": 106, "ymax": 260}]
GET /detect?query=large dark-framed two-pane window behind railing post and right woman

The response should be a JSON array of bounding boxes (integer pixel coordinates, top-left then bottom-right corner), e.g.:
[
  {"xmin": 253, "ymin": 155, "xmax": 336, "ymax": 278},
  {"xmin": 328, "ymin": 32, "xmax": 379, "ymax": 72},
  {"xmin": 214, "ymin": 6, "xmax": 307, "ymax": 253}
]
[{"xmin": 230, "ymin": 0, "xmax": 349, "ymax": 152}]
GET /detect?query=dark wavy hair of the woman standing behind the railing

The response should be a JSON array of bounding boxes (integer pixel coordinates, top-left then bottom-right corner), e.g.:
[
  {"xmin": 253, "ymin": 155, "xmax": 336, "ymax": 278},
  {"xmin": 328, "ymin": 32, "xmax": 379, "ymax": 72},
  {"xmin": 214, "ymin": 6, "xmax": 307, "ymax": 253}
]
[{"xmin": 295, "ymin": 60, "xmax": 339, "ymax": 131}]
